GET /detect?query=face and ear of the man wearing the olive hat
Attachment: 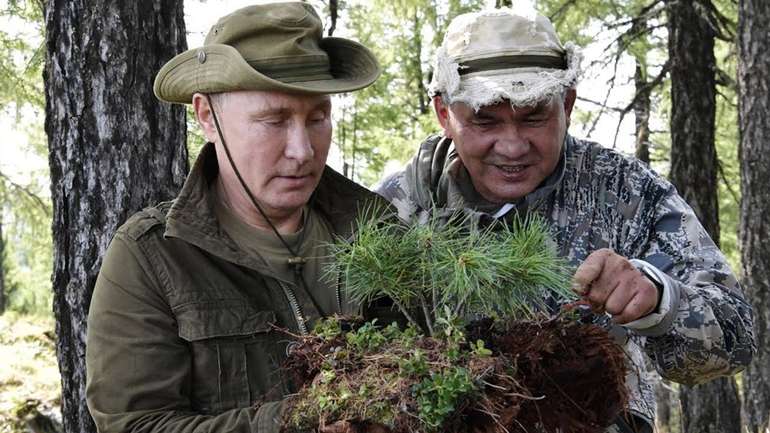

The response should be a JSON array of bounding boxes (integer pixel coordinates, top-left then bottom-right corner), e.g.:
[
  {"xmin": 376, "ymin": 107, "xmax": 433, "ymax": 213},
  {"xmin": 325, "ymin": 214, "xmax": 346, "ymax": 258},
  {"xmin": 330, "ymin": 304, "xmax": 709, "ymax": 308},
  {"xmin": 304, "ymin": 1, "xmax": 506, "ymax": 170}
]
[{"xmin": 193, "ymin": 91, "xmax": 332, "ymax": 218}]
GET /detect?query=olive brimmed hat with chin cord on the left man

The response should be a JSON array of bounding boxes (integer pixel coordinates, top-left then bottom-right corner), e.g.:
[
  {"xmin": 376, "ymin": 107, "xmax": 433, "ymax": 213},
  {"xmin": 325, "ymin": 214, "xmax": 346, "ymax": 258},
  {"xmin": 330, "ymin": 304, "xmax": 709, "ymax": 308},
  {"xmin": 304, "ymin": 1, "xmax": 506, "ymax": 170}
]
[{"xmin": 154, "ymin": 2, "xmax": 380, "ymax": 104}]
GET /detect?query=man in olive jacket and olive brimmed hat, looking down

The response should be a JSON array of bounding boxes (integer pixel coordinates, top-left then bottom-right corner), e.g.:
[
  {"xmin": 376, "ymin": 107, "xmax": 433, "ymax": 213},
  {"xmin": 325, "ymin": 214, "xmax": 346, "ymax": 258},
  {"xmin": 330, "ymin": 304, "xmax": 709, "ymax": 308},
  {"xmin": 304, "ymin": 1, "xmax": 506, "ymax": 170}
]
[{"xmin": 86, "ymin": 2, "xmax": 379, "ymax": 433}]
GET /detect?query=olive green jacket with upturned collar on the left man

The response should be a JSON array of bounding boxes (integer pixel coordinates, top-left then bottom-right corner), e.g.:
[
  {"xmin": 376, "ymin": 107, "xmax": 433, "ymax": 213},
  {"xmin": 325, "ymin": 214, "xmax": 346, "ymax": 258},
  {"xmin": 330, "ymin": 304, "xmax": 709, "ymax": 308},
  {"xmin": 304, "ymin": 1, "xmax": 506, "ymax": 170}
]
[{"xmin": 86, "ymin": 145, "xmax": 376, "ymax": 433}]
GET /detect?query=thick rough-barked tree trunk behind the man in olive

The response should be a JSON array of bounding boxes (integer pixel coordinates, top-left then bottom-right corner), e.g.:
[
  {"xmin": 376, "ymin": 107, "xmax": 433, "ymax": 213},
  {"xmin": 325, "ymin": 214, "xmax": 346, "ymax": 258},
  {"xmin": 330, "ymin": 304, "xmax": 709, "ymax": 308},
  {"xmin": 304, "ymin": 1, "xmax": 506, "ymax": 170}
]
[{"xmin": 44, "ymin": 0, "xmax": 187, "ymax": 433}]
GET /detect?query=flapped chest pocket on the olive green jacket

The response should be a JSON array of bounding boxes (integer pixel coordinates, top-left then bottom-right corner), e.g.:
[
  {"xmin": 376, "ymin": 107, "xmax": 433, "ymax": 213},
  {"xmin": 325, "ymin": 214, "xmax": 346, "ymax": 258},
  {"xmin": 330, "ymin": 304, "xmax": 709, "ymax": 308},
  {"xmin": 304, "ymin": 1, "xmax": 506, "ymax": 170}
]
[{"xmin": 175, "ymin": 300, "xmax": 288, "ymax": 414}]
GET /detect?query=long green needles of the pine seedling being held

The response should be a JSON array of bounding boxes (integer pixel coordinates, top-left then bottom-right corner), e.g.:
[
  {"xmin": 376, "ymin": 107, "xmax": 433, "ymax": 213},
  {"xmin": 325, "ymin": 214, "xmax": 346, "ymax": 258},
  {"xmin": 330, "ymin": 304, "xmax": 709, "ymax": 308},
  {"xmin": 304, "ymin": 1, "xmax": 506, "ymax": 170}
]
[{"xmin": 328, "ymin": 208, "xmax": 574, "ymax": 335}]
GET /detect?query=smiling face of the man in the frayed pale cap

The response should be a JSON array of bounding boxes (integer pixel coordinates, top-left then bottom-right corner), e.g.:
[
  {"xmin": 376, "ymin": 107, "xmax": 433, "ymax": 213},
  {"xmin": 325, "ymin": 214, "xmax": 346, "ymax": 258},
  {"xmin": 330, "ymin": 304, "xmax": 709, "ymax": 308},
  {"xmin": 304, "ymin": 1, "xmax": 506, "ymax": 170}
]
[{"xmin": 434, "ymin": 89, "xmax": 575, "ymax": 203}]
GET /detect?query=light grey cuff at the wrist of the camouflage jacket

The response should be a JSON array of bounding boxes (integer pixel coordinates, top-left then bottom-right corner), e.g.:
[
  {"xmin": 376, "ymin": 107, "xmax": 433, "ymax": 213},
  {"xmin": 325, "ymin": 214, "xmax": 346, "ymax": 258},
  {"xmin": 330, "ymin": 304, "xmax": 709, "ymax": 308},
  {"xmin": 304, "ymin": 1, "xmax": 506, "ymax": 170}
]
[{"xmin": 623, "ymin": 259, "xmax": 679, "ymax": 337}]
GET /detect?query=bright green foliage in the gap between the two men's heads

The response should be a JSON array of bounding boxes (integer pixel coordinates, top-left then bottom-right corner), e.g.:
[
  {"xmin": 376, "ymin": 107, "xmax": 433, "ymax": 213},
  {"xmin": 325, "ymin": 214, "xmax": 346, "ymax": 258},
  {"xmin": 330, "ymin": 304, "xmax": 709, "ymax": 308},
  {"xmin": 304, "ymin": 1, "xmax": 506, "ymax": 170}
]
[{"xmin": 334, "ymin": 0, "xmax": 483, "ymax": 185}]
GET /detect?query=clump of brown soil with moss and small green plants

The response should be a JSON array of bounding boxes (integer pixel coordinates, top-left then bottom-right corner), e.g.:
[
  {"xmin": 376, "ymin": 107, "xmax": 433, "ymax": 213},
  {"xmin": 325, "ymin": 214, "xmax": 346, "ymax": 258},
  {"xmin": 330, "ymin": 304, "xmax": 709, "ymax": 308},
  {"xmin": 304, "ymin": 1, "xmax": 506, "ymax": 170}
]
[{"xmin": 284, "ymin": 316, "xmax": 627, "ymax": 433}]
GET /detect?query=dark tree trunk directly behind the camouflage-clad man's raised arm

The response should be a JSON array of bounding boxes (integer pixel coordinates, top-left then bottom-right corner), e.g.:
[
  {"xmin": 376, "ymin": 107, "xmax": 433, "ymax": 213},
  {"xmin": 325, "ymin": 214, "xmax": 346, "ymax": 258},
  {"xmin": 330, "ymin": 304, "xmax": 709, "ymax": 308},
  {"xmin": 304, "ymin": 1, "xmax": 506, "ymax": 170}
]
[{"xmin": 668, "ymin": 0, "xmax": 741, "ymax": 433}]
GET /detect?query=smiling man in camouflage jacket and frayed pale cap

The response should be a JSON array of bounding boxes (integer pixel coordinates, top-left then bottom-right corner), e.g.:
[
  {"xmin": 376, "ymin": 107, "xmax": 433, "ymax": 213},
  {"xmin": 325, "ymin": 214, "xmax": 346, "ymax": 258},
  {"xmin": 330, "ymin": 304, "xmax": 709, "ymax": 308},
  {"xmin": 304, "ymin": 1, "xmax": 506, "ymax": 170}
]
[{"xmin": 378, "ymin": 9, "xmax": 756, "ymax": 432}]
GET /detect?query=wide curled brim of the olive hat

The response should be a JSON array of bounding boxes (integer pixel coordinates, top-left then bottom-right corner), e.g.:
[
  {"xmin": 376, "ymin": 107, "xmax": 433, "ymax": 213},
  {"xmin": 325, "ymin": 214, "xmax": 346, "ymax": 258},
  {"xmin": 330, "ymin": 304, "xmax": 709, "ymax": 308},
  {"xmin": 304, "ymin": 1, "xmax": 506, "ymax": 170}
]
[{"xmin": 153, "ymin": 37, "xmax": 380, "ymax": 104}]
